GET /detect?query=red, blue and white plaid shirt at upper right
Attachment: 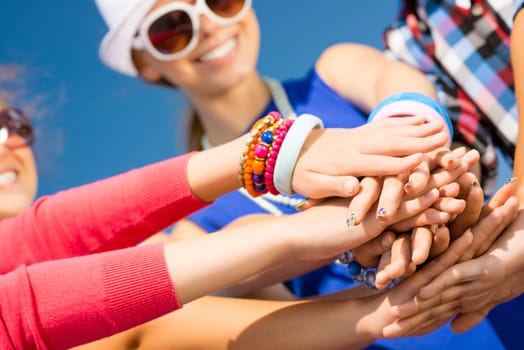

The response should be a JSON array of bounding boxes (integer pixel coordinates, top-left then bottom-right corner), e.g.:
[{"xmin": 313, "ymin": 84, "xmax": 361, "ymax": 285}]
[{"xmin": 384, "ymin": 0, "xmax": 524, "ymax": 192}]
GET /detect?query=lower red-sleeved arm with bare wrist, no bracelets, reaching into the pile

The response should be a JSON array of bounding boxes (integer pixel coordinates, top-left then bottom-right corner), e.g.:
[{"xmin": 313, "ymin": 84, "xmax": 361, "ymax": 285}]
[{"xmin": 0, "ymin": 193, "xmax": 437, "ymax": 349}]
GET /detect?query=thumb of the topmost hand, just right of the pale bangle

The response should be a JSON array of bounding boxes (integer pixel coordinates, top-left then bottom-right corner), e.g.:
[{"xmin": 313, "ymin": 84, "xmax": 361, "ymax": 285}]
[{"xmin": 293, "ymin": 173, "xmax": 360, "ymax": 199}]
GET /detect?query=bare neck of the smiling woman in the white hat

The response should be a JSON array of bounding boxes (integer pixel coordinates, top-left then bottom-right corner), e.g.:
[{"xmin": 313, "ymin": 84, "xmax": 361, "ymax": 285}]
[{"xmin": 190, "ymin": 74, "xmax": 271, "ymax": 145}]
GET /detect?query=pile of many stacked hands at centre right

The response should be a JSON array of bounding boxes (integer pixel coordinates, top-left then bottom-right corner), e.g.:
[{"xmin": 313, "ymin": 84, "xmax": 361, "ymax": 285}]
[{"xmin": 286, "ymin": 117, "xmax": 519, "ymax": 338}]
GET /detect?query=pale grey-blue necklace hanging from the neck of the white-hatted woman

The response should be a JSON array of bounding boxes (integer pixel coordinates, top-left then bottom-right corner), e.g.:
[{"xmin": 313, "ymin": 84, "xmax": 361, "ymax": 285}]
[{"xmin": 201, "ymin": 77, "xmax": 303, "ymax": 215}]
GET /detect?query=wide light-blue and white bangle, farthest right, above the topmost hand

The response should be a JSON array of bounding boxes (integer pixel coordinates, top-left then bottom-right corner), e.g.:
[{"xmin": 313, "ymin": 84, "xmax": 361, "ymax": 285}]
[{"xmin": 368, "ymin": 92, "xmax": 453, "ymax": 146}]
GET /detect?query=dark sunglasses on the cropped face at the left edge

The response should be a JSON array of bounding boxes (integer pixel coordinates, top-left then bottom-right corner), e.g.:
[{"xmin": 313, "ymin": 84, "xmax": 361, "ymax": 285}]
[{"xmin": 0, "ymin": 108, "xmax": 35, "ymax": 148}]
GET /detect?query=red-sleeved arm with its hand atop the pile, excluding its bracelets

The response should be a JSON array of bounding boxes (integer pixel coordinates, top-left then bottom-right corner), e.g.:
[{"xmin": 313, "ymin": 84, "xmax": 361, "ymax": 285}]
[{"xmin": 0, "ymin": 118, "xmax": 444, "ymax": 272}]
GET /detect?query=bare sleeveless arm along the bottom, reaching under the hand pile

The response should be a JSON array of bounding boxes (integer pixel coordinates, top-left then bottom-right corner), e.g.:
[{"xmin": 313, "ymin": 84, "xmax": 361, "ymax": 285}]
[{"xmin": 71, "ymin": 220, "xmax": 471, "ymax": 350}]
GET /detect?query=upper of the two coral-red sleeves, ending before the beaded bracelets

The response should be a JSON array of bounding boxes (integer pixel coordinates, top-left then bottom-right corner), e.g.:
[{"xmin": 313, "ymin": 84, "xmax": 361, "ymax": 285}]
[{"xmin": 0, "ymin": 155, "xmax": 206, "ymax": 272}]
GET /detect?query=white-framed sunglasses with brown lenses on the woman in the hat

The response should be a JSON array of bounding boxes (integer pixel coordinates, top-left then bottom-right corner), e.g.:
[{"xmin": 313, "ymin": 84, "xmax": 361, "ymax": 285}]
[{"xmin": 133, "ymin": 0, "xmax": 252, "ymax": 61}]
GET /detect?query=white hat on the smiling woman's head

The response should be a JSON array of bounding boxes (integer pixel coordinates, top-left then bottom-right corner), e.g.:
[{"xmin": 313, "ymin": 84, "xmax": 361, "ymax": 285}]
[{"xmin": 95, "ymin": 0, "xmax": 156, "ymax": 76}]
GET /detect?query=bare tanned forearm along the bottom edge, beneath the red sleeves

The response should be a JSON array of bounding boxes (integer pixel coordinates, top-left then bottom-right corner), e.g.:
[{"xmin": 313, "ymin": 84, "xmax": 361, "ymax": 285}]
[{"xmin": 73, "ymin": 297, "xmax": 368, "ymax": 350}]
